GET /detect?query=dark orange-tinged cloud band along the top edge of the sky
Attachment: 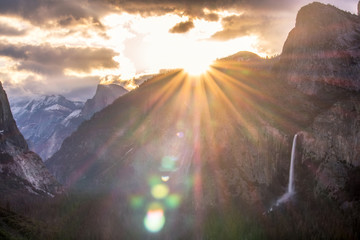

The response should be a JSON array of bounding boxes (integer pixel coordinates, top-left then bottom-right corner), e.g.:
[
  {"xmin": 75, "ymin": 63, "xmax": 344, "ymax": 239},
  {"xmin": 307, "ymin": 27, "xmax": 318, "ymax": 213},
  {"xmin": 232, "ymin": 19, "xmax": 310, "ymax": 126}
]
[{"xmin": 0, "ymin": 0, "xmax": 295, "ymax": 27}]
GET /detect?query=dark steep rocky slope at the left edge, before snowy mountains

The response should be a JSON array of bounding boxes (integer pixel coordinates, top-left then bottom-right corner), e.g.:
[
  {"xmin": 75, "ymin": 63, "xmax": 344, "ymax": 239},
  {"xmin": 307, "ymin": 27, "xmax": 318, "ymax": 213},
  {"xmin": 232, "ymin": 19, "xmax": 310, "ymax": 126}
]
[{"xmin": 0, "ymin": 83, "xmax": 61, "ymax": 201}]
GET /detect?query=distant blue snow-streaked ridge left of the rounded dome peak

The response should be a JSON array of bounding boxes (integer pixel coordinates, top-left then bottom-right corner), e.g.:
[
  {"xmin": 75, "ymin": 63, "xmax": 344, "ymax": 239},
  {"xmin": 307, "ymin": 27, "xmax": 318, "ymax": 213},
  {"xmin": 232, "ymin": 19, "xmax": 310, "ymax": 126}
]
[{"xmin": 12, "ymin": 95, "xmax": 83, "ymax": 161}]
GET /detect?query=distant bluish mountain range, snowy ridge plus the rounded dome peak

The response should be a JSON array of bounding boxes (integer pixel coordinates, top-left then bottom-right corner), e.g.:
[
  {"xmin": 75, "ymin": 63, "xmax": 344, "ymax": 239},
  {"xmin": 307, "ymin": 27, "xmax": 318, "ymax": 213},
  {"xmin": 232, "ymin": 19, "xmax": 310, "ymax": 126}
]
[{"xmin": 12, "ymin": 84, "xmax": 127, "ymax": 161}]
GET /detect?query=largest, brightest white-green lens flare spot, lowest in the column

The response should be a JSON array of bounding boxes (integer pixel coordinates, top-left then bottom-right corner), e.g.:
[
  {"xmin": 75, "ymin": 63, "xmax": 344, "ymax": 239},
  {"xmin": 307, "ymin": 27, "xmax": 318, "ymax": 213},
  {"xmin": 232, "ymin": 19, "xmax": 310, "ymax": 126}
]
[{"xmin": 144, "ymin": 203, "xmax": 165, "ymax": 233}]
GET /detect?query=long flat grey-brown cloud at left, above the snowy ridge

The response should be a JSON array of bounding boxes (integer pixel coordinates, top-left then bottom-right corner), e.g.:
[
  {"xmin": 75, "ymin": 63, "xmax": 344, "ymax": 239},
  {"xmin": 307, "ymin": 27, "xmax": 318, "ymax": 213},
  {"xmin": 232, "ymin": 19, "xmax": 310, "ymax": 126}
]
[{"xmin": 0, "ymin": 43, "xmax": 118, "ymax": 75}]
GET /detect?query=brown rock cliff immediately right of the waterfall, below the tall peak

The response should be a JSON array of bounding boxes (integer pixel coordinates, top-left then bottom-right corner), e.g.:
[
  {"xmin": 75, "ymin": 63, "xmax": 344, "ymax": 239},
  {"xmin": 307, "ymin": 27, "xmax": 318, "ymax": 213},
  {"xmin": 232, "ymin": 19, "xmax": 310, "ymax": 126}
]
[{"xmin": 301, "ymin": 95, "xmax": 360, "ymax": 204}]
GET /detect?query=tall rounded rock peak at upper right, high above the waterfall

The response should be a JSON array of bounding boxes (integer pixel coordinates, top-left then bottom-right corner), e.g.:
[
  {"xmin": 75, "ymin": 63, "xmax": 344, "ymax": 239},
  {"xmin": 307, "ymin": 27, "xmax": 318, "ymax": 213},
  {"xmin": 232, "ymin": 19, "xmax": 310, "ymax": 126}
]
[{"xmin": 280, "ymin": 3, "xmax": 360, "ymax": 98}]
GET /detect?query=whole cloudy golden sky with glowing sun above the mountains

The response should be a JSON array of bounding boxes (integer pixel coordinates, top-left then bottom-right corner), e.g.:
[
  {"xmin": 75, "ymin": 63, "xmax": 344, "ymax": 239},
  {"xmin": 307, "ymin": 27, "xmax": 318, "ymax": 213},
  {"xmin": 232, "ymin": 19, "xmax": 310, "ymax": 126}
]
[{"xmin": 0, "ymin": 0, "xmax": 358, "ymax": 102}]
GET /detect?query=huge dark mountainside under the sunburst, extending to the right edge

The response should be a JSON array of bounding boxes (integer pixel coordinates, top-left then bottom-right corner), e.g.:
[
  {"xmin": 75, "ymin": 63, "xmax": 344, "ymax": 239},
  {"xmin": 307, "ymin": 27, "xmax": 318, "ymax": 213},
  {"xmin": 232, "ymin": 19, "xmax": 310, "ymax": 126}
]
[{"xmin": 46, "ymin": 3, "xmax": 360, "ymax": 239}]
